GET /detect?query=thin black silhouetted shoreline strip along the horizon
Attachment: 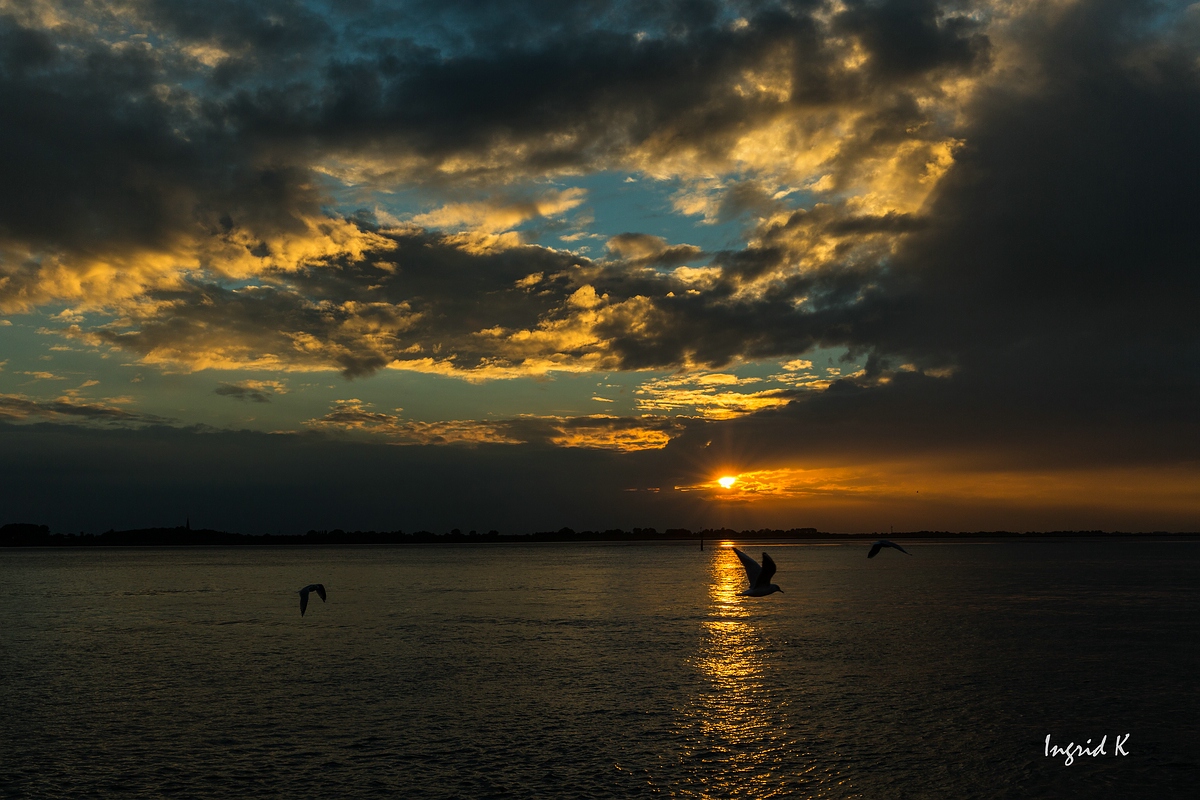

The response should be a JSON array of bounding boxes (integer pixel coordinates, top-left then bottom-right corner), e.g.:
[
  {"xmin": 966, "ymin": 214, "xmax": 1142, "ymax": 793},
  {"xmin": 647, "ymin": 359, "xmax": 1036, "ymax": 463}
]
[{"xmin": 0, "ymin": 523, "xmax": 1200, "ymax": 547}]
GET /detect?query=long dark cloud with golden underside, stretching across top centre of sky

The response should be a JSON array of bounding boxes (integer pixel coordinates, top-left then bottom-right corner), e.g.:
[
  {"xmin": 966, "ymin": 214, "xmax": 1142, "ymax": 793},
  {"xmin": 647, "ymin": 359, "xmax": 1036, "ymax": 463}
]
[{"xmin": 260, "ymin": 4, "xmax": 986, "ymax": 176}]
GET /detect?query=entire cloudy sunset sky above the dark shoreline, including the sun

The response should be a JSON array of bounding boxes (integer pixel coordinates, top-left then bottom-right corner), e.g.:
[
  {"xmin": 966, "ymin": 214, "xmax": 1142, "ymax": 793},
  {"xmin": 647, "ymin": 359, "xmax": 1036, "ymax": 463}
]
[{"xmin": 0, "ymin": 0, "xmax": 1200, "ymax": 533}]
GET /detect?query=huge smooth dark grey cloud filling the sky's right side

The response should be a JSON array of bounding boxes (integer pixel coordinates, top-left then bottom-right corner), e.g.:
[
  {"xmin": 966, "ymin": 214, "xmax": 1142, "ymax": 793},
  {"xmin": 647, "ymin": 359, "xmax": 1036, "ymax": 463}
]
[{"xmin": 638, "ymin": 4, "xmax": 1200, "ymax": 468}]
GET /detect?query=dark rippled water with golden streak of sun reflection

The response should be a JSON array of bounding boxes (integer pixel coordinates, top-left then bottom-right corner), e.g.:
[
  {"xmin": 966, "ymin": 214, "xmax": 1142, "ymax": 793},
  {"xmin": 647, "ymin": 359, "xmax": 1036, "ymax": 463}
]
[{"xmin": 0, "ymin": 541, "xmax": 1200, "ymax": 799}]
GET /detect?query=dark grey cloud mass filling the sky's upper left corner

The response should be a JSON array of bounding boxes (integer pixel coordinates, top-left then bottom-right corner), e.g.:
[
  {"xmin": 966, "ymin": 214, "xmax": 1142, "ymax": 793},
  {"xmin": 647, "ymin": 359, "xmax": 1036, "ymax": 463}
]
[{"xmin": 0, "ymin": 10, "xmax": 317, "ymax": 248}]
